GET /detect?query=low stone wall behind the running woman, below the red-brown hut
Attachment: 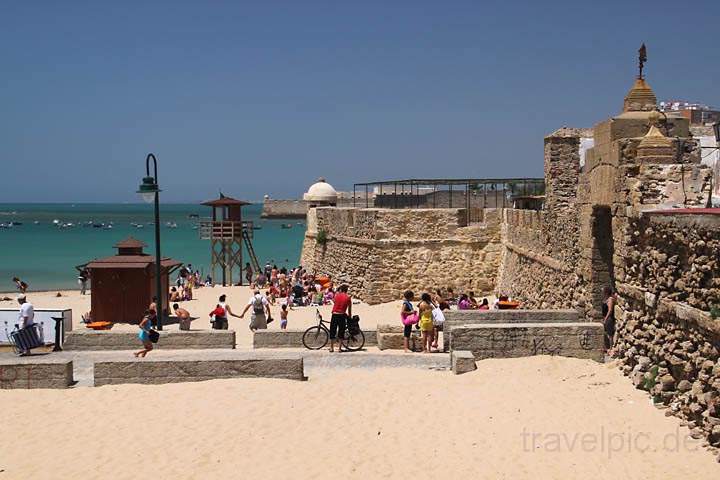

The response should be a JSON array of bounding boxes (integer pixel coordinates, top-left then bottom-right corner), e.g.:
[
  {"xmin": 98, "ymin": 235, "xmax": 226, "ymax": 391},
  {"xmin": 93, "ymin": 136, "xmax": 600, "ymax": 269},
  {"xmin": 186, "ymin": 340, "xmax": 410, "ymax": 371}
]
[{"xmin": 63, "ymin": 330, "xmax": 235, "ymax": 351}]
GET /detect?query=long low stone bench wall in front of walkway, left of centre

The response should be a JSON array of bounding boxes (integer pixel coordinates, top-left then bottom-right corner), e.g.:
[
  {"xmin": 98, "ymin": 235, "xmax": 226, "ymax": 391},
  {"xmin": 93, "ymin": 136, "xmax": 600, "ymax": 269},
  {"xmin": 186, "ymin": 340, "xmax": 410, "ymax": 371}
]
[{"xmin": 94, "ymin": 350, "xmax": 306, "ymax": 386}]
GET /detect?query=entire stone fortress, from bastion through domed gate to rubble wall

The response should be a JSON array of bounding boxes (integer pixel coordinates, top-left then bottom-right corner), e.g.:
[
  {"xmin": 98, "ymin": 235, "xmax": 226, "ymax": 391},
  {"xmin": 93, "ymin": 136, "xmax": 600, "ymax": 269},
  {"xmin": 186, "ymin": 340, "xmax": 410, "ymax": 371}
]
[{"xmin": 302, "ymin": 70, "xmax": 720, "ymax": 447}]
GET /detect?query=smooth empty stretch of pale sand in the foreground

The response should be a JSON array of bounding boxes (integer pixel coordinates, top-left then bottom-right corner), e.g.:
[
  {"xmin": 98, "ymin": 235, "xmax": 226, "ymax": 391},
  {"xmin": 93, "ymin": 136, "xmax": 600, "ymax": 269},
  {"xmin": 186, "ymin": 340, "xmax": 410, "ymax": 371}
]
[{"xmin": 0, "ymin": 357, "xmax": 720, "ymax": 479}]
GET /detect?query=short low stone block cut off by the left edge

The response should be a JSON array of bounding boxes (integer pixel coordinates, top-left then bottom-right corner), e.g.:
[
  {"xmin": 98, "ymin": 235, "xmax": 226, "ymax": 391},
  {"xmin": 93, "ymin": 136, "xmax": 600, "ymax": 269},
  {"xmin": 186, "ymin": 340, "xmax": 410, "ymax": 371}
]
[{"xmin": 0, "ymin": 353, "xmax": 73, "ymax": 389}]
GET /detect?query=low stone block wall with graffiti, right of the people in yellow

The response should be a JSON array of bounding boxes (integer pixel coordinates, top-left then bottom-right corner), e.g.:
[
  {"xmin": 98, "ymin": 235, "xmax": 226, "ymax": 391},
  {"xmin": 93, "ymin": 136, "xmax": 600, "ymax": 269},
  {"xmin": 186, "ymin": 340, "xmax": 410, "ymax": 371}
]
[{"xmin": 450, "ymin": 322, "xmax": 605, "ymax": 362}]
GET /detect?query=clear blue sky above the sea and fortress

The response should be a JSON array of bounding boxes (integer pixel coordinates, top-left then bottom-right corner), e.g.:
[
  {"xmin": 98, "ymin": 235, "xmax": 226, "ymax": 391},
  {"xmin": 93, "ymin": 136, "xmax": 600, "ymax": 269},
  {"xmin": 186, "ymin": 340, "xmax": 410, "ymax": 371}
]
[{"xmin": 0, "ymin": 0, "xmax": 720, "ymax": 202}]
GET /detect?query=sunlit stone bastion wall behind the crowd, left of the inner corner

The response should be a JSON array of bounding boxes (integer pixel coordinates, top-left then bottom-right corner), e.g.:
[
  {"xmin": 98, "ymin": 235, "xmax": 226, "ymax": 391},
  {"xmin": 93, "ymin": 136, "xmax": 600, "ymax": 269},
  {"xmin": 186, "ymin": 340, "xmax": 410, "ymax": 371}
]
[{"xmin": 301, "ymin": 207, "xmax": 501, "ymax": 303}]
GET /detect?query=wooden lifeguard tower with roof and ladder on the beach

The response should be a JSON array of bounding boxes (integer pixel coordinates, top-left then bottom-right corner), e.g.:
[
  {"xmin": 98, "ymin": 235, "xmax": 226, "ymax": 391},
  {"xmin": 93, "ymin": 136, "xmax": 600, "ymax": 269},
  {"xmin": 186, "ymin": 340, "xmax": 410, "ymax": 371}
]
[{"xmin": 200, "ymin": 193, "xmax": 260, "ymax": 285}]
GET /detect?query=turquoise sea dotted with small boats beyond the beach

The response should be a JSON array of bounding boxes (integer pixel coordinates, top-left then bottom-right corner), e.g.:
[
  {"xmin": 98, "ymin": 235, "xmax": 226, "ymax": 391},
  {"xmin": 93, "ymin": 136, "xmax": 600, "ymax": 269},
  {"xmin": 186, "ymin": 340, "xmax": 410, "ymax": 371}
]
[{"xmin": 0, "ymin": 203, "xmax": 305, "ymax": 292}]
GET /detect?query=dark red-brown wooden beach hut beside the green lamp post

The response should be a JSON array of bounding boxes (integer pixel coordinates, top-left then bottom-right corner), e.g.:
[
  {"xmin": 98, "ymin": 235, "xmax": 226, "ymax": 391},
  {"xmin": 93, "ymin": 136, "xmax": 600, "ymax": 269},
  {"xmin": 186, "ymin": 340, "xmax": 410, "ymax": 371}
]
[{"xmin": 86, "ymin": 237, "xmax": 182, "ymax": 323}]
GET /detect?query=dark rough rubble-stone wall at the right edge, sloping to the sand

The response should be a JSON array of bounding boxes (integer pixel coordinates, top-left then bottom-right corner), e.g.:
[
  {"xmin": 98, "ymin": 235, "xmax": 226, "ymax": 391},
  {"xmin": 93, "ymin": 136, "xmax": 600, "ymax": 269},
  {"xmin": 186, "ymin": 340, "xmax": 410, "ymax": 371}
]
[{"xmin": 615, "ymin": 214, "xmax": 720, "ymax": 447}]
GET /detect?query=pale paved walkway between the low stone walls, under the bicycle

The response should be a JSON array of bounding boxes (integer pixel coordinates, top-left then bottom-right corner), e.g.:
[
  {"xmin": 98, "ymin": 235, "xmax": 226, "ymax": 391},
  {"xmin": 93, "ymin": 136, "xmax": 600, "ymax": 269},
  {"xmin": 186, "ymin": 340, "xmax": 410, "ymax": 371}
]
[{"xmin": 0, "ymin": 348, "xmax": 450, "ymax": 387}]
